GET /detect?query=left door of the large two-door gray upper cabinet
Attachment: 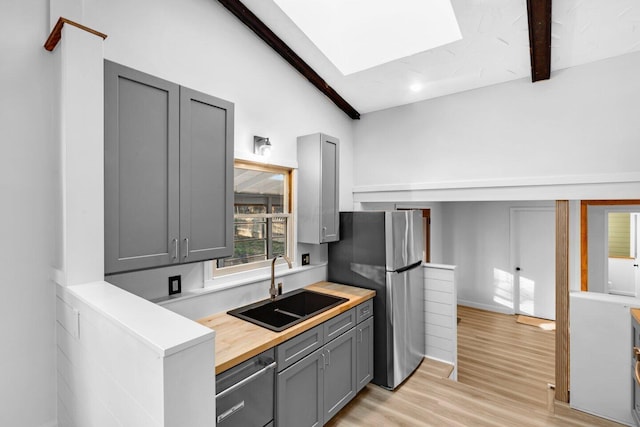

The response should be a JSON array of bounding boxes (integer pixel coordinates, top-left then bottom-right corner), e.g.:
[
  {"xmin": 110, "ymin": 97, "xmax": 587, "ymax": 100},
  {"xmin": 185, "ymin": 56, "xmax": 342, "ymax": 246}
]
[{"xmin": 104, "ymin": 61, "xmax": 179, "ymax": 274}]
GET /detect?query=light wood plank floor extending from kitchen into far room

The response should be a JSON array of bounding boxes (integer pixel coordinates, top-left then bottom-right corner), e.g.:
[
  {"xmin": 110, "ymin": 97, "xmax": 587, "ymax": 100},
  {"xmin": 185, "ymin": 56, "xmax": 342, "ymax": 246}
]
[{"xmin": 327, "ymin": 307, "xmax": 620, "ymax": 427}]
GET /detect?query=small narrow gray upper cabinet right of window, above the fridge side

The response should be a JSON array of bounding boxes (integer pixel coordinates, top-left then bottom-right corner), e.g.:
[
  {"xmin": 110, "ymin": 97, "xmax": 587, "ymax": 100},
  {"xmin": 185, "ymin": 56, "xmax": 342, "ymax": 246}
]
[{"xmin": 298, "ymin": 133, "xmax": 340, "ymax": 244}]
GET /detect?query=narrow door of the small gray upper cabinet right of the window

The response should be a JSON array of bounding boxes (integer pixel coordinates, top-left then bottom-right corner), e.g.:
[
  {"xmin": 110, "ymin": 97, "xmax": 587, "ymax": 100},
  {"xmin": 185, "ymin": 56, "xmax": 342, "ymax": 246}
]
[{"xmin": 320, "ymin": 134, "xmax": 340, "ymax": 243}]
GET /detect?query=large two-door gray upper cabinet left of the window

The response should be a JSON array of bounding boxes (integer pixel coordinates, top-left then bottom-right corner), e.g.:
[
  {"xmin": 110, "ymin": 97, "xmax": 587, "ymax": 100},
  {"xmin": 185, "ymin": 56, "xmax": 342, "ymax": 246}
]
[{"xmin": 104, "ymin": 61, "xmax": 233, "ymax": 274}]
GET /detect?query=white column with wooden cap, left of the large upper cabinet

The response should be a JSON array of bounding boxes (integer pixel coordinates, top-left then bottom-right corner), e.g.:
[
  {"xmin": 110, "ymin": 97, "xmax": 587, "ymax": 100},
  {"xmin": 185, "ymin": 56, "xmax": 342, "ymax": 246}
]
[{"xmin": 55, "ymin": 25, "xmax": 104, "ymax": 286}]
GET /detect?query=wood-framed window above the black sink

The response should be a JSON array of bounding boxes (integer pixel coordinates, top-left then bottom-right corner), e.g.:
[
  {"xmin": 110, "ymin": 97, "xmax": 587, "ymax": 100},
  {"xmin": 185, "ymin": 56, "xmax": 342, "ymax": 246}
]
[{"xmin": 214, "ymin": 161, "xmax": 293, "ymax": 276}]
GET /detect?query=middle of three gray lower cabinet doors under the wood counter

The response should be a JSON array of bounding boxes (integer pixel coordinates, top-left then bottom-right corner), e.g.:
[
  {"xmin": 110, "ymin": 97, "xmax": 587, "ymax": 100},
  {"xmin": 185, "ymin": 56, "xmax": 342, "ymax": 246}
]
[{"xmin": 324, "ymin": 328, "xmax": 357, "ymax": 422}]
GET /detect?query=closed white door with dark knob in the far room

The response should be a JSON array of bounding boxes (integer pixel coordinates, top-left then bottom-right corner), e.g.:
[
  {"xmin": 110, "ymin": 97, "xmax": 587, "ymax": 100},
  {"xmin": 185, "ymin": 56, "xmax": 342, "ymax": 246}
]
[{"xmin": 511, "ymin": 208, "xmax": 556, "ymax": 320}]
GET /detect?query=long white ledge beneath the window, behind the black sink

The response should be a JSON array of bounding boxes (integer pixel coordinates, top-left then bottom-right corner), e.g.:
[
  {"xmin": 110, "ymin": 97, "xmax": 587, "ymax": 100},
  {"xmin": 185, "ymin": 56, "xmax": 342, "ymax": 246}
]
[{"xmin": 151, "ymin": 262, "xmax": 327, "ymax": 305}]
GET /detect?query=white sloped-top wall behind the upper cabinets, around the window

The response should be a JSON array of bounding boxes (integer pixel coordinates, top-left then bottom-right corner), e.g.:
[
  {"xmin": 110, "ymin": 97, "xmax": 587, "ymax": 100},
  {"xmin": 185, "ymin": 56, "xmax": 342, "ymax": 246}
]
[{"xmin": 88, "ymin": 0, "xmax": 360, "ymax": 299}]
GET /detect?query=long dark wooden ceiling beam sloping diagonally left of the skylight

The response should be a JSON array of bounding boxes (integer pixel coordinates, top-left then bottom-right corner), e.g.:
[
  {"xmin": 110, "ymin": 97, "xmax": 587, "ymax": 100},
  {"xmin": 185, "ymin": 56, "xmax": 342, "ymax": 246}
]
[{"xmin": 218, "ymin": 0, "xmax": 360, "ymax": 120}]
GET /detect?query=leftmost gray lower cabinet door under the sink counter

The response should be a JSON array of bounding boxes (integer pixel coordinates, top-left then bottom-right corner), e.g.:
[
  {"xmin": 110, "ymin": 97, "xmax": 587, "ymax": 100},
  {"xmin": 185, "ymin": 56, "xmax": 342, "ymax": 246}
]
[{"xmin": 276, "ymin": 349, "xmax": 325, "ymax": 427}]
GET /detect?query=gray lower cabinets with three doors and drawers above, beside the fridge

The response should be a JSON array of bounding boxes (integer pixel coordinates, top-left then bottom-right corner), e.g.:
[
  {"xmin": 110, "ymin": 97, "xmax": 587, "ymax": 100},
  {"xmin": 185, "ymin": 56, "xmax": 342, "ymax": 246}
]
[{"xmin": 275, "ymin": 301, "xmax": 373, "ymax": 427}]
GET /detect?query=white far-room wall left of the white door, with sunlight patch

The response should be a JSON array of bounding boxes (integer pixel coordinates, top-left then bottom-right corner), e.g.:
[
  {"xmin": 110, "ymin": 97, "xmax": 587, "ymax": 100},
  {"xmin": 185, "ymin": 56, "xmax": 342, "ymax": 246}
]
[{"xmin": 442, "ymin": 201, "xmax": 555, "ymax": 313}]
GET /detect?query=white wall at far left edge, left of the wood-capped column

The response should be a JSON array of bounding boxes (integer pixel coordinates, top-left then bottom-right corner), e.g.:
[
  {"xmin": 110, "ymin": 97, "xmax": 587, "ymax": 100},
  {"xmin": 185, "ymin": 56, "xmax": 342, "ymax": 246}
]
[{"xmin": 0, "ymin": 0, "xmax": 57, "ymax": 426}]
